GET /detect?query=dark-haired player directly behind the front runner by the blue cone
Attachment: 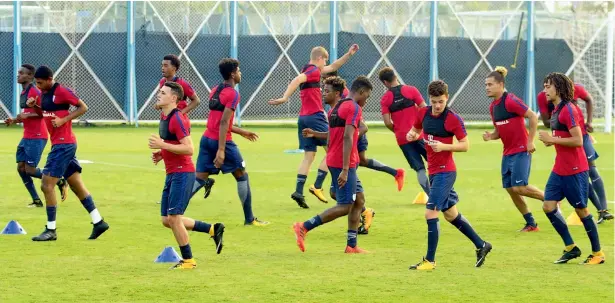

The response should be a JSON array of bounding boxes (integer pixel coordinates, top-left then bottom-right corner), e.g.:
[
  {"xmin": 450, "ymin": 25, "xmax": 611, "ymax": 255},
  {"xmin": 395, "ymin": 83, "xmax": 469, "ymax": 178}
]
[{"xmin": 192, "ymin": 58, "xmax": 269, "ymax": 226}]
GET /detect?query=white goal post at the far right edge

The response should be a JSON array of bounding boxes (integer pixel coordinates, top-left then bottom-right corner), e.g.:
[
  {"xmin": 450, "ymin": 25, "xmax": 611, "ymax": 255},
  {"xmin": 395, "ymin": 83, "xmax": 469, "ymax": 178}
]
[{"xmin": 604, "ymin": 9, "xmax": 615, "ymax": 134}]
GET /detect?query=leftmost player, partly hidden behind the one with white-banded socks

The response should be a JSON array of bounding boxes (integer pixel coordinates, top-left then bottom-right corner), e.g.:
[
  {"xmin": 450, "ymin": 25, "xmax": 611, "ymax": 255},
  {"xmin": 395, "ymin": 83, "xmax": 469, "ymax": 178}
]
[{"xmin": 4, "ymin": 64, "xmax": 68, "ymax": 207}]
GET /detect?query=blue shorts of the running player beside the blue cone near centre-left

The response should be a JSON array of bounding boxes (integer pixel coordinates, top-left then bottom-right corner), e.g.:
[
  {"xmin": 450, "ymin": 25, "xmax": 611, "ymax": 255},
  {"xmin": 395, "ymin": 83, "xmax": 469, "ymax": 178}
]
[{"xmin": 160, "ymin": 172, "xmax": 196, "ymax": 217}]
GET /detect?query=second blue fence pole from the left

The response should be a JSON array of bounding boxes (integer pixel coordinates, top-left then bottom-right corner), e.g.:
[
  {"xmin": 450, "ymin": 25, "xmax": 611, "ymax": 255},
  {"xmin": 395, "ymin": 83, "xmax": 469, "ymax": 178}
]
[{"xmin": 124, "ymin": 0, "xmax": 139, "ymax": 127}]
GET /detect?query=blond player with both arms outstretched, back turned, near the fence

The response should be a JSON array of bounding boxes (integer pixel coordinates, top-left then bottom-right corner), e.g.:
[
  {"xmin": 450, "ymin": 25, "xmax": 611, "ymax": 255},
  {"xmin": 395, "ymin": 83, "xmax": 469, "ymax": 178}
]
[{"xmin": 269, "ymin": 44, "xmax": 359, "ymax": 208}]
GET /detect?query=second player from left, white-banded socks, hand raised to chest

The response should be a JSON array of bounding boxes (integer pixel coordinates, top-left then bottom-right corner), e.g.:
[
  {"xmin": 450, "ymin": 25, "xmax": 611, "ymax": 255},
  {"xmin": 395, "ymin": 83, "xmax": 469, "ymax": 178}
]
[{"xmin": 28, "ymin": 66, "xmax": 109, "ymax": 241}]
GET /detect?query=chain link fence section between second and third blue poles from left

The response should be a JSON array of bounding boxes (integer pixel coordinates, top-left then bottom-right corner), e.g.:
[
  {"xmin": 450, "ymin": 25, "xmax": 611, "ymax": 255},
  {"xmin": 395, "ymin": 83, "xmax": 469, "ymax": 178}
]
[{"xmin": 135, "ymin": 1, "xmax": 230, "ymax": 120}]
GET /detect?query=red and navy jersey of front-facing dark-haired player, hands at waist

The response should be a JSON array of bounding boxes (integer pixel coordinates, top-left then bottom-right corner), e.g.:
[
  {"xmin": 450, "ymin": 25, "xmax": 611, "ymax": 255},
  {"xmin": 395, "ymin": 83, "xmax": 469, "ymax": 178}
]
[{"xmin": 414, "ymin": 106, "xmax": 467, "ymax": 175}]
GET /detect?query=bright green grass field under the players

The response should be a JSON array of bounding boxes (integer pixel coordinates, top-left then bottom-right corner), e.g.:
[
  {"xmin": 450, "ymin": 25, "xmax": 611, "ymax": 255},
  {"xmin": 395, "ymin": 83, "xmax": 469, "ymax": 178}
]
[{"xmin": 0, "ymin": 126, "xmax": 615, "ymax": 302}]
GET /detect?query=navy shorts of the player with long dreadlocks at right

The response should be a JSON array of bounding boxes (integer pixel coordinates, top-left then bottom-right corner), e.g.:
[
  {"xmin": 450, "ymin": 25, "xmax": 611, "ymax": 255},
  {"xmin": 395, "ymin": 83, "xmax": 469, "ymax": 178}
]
[{"xmin": 545, "ymin": 171, "xmax": 589, "ymax": 208}]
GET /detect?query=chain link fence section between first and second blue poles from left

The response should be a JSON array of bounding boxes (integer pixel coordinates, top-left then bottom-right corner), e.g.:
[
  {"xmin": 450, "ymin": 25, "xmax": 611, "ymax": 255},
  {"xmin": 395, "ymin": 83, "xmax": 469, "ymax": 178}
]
[{"xmin": 21, "ymin": 1, "xmax": 128, "ymax": 121}]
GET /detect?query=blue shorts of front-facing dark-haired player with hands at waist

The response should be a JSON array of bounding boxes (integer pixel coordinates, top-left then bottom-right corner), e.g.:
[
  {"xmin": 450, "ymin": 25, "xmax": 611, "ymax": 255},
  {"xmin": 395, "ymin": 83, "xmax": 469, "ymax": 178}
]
[{"xmin": 425, "ymin": 171, "xmax": 459, "ymax": 211}]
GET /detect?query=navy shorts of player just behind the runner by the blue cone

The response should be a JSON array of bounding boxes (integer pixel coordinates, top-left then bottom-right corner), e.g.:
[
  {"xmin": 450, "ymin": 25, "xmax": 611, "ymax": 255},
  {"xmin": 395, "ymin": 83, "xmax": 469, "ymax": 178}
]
[{"xmin": 196, "ymin": 136, "xmax": 246, "ymax": 175}]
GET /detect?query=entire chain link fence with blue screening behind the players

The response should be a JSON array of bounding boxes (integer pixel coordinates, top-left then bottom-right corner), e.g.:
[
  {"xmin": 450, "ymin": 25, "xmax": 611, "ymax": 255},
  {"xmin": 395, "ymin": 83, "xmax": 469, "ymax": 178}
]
[{"xmin": 0, "ymin": 1, "xmax": 613, "ymax": 126}]
